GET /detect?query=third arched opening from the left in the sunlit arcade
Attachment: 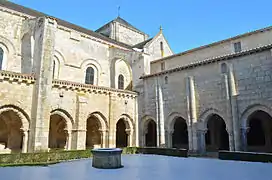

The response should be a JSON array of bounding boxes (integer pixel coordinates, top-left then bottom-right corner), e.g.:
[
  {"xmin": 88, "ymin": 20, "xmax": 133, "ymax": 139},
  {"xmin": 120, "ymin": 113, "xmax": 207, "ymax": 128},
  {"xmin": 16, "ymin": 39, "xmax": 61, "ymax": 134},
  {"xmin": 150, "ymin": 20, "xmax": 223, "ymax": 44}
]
[{"xmin": 86, "ymin": 116, "xmax": 102, "ymax": 149}]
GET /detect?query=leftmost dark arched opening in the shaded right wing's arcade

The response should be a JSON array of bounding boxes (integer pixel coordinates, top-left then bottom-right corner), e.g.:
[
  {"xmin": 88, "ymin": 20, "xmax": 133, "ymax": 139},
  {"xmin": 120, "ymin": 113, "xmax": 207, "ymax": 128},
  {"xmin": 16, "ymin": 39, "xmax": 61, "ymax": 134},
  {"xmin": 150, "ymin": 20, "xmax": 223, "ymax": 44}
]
[{"xmin": 145, "ymin": 120, "xmax": 157, "ymax": 147}]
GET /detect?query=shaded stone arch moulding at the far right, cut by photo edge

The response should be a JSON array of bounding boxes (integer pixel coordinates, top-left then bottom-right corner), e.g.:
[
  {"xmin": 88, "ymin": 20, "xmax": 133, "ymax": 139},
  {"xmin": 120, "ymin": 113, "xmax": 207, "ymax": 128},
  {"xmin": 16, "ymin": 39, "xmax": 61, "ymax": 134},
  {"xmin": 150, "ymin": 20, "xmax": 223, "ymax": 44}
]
[{"xmin": 240, "ymin": 104, "xmax": 272, "ymax": 129}]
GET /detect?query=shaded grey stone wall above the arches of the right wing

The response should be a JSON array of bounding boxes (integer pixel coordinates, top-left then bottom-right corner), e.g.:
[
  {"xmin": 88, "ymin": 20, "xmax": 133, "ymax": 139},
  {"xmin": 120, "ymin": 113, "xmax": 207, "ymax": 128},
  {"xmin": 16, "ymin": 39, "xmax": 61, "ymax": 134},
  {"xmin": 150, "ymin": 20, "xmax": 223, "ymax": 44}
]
[{"xmin": 139, "ymin": 49, "xmax": 272, "ymax": 150}]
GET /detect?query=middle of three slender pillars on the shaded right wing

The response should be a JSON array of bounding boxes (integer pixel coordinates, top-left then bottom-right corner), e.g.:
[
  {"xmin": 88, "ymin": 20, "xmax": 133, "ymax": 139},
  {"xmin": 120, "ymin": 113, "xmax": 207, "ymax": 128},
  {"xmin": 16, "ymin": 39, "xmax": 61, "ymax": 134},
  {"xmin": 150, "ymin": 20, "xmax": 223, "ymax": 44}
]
[{"xmin": 186, "ymin": 76, "xmax": 198, "ymax": 151}]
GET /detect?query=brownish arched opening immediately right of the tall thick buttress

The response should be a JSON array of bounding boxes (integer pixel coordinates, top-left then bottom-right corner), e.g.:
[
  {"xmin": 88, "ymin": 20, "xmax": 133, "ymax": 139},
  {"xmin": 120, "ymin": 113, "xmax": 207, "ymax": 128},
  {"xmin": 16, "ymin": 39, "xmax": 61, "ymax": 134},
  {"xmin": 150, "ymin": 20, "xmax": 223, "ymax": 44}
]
[{"xmin": 48, "ymin": 114, "xmax": 68, "ymax": 149}]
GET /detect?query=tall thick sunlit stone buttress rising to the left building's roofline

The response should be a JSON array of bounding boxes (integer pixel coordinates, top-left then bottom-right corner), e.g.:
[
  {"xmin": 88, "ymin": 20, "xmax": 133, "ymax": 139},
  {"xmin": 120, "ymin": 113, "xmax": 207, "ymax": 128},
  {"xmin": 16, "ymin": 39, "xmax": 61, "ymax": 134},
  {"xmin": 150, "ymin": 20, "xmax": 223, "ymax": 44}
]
[{"xmin": 29, "ymin": 17, "xmax": 57, "ymax": 152}]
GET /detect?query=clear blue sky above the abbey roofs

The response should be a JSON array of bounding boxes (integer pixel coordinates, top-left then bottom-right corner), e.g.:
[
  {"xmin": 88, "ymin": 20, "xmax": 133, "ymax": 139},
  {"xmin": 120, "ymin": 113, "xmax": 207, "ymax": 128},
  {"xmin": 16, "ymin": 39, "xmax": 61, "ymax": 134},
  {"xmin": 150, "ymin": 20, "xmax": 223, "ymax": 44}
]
[{"xmin": 12, "ymin": 0, "xmax": 272, "ymax": 53}]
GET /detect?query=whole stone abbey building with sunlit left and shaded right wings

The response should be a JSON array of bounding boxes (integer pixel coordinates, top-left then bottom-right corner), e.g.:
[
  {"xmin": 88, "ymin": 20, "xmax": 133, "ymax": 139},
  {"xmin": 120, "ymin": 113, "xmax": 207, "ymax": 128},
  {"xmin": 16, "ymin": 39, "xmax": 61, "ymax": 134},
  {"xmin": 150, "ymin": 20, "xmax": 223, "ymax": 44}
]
[{"xmin": 0, "ymin": 0, "xmax": 272, "ymax": 153}]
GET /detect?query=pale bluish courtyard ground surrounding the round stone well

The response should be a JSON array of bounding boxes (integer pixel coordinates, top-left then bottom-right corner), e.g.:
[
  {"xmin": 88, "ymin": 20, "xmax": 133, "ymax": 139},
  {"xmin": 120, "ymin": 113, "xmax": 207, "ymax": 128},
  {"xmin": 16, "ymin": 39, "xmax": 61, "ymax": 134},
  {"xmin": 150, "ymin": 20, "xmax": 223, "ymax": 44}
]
[{"xmin": 0, "ymin": 155, "xmax": 272, "ymax": 180}]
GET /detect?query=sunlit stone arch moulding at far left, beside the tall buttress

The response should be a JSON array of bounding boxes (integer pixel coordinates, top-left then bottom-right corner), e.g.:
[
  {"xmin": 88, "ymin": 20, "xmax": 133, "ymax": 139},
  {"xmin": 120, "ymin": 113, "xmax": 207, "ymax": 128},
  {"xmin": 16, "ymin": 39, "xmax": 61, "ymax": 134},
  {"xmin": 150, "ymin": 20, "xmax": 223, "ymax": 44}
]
[{"xmin": 0, "ymin": 105, "xmax": 30, "ymax": 131}]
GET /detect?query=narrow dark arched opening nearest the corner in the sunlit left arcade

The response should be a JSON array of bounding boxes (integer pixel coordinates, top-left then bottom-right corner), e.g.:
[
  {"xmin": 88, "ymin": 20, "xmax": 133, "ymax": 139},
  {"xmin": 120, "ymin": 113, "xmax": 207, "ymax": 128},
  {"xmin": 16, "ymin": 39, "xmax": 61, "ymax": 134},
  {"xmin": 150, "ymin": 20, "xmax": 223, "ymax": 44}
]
[{"xmin": 116, "ymin": 119, "xmax": 128, "ymax": 147}]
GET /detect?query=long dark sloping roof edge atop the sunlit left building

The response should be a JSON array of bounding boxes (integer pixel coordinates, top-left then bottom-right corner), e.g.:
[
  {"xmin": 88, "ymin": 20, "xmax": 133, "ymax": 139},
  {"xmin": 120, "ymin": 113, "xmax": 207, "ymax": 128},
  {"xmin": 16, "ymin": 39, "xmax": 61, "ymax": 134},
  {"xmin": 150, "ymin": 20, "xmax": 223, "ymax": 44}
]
[{"xmin": 0, "ymin": 0, "xmax": 131, "ymax": 49}]
